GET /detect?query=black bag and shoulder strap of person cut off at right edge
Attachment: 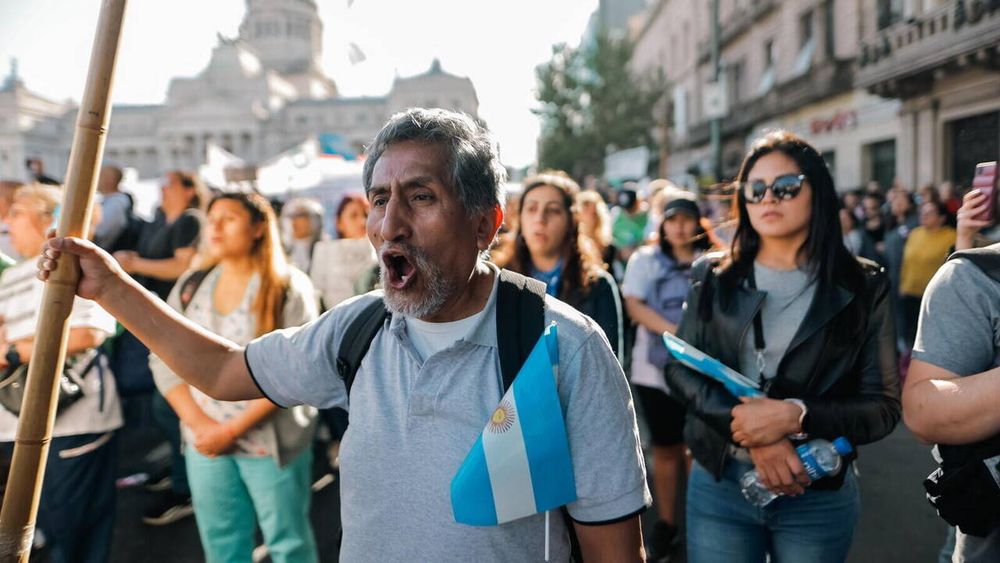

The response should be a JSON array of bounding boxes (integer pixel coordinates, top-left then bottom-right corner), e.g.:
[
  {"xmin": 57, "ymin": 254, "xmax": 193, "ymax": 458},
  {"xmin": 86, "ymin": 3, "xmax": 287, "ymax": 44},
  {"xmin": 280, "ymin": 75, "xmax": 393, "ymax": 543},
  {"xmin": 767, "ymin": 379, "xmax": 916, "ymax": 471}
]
[{"xmin": 924, "ymin": 244, "xmax": 1000, "ymax": 537}]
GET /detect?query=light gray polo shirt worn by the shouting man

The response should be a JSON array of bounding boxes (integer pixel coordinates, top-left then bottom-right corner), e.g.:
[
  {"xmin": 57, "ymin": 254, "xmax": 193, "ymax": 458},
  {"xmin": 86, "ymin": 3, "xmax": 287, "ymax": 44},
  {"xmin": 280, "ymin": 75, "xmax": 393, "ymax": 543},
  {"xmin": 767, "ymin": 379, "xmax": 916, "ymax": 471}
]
[{"xmin": 246, "ymin": 268, "xmax": 650, "ymax": 562}]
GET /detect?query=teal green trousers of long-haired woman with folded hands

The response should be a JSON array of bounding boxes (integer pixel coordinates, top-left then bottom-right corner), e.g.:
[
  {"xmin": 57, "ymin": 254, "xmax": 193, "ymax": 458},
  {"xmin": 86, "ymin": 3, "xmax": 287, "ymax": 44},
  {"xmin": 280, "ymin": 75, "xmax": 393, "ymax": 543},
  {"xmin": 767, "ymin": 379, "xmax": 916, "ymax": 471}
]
[{"xmin": 184, "ymin": 447, "xmax": 319, "ymax": 563}]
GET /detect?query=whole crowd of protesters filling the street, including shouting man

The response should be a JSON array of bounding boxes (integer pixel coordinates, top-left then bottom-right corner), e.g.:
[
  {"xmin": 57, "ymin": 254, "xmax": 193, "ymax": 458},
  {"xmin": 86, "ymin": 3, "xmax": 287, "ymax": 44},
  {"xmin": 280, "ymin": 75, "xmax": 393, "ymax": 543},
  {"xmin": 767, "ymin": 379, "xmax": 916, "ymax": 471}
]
[{"xmin": 0, "ymin": 109, "xmax": 1000, "ymax": 563}]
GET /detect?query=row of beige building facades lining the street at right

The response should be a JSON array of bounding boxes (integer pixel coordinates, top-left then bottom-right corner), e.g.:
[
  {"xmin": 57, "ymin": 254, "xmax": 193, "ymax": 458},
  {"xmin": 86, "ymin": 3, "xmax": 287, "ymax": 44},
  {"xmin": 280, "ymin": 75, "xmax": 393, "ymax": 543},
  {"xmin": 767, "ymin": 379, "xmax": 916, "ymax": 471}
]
[{"xmin": 632, "ymin": 0, "xmax": 1000, "ymax": 190}]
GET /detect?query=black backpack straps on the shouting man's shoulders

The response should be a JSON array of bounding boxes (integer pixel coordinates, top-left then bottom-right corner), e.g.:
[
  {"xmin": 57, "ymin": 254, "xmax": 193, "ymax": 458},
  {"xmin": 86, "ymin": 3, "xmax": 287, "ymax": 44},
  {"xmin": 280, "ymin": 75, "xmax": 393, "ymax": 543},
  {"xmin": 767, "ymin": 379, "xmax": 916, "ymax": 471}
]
[{"xmin": 337, "ymin": 270, "xmax": 583, "ymax": 561}]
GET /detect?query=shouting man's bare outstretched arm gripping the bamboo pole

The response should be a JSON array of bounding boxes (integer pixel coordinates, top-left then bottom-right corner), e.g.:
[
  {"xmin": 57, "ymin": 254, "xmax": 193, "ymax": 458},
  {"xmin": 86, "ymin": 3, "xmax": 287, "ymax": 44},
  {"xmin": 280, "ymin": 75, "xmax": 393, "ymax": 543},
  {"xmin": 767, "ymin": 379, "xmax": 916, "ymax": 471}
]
[{"xmin": 38, "ymin": 237, "xmax": 263, "ymax": 401}]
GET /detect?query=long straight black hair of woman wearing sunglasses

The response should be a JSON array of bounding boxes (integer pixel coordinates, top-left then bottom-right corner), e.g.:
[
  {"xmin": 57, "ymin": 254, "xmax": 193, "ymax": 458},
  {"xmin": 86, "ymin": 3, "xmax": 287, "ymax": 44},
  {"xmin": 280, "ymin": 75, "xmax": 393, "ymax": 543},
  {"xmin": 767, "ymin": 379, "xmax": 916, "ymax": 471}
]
[{"xmin": 701, "ymin": 131, "xmax": 865, "ymax": 337}]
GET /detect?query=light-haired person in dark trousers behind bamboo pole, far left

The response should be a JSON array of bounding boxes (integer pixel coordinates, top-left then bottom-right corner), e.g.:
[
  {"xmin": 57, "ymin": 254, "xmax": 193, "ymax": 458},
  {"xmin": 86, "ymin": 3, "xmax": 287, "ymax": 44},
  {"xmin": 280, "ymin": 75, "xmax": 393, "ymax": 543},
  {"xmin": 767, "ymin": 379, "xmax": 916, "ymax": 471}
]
[{"xmin": 0, "ymin": 184, "xmax": 122, "ymax": 563}]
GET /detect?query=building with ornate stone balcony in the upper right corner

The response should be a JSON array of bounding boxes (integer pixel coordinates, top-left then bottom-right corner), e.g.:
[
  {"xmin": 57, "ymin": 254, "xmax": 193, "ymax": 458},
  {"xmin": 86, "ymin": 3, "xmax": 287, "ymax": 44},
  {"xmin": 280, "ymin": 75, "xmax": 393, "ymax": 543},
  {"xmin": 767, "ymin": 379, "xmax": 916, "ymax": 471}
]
[{"xmin": 856, "ymin": 0, "xmax": 1000, "ymax": 188}]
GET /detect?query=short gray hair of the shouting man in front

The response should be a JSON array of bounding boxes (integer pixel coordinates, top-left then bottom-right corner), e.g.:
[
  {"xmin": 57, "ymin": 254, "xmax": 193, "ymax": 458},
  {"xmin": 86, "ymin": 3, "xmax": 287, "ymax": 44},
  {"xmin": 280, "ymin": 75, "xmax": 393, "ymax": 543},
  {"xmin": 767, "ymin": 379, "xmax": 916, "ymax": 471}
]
[{"xmin": 362, "ymin": 108, "xmax": 507, "ymax": 215}]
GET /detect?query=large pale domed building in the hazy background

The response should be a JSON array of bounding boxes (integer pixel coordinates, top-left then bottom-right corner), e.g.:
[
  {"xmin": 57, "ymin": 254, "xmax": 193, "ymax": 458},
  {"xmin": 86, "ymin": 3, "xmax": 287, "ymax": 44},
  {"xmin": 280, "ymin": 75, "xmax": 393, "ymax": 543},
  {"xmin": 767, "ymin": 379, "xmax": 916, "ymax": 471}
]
[{"xmin": 0, "ymin": 0, "xmax": 479, "ymax": 181}]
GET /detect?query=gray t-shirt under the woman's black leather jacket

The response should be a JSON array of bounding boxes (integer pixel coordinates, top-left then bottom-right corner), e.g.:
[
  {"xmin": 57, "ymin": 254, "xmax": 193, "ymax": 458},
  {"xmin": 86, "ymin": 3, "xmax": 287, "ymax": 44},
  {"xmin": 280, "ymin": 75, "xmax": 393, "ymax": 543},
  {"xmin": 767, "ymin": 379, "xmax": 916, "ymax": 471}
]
[{"xmin": 740, "ymin": 262, "xmax": 816, "ymax": 380}]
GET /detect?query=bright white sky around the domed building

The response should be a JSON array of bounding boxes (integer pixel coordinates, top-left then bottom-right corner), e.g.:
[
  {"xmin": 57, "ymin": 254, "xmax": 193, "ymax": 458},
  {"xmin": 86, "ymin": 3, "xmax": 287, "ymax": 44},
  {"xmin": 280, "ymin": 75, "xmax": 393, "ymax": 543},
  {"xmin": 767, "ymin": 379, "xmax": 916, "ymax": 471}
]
[{"xmin": 0, "ymin": 0, "xmax": 597, "ymax": 166}]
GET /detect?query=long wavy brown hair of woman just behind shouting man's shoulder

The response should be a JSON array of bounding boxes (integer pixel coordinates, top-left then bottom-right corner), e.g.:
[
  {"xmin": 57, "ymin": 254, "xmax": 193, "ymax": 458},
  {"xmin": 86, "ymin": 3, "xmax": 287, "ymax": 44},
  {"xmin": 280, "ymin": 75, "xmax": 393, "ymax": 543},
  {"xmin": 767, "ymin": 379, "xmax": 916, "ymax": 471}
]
[{"xmin": 507, "ymin": 170, "xmax": 595, "ymax": 301}]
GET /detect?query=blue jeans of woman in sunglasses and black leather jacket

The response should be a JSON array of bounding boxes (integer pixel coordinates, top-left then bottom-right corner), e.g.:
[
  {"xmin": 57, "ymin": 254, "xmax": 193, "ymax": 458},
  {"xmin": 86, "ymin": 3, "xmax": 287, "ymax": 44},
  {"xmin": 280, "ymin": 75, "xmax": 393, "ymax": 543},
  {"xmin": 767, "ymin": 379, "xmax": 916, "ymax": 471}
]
[{"xmin": 687, "ymin": 461, "xmax": 860, "ymax": 563}]
